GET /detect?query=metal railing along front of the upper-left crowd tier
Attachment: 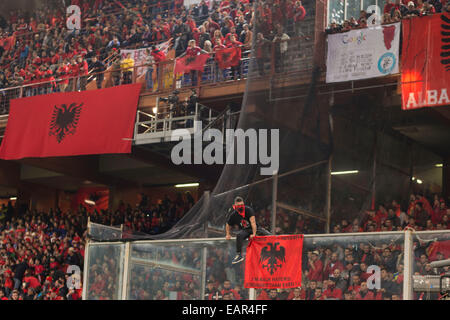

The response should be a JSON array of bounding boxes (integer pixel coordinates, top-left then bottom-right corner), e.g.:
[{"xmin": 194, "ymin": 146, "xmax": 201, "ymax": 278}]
[{"xmin": 0, "ymin": 37, "xmax": 313, "ymax": 114}]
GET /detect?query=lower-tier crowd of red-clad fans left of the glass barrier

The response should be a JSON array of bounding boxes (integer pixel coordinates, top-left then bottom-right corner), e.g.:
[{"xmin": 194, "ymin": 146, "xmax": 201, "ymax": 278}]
[{"xmin": 0, "ymin": 193, "xmax": 194, "ymax": 300}]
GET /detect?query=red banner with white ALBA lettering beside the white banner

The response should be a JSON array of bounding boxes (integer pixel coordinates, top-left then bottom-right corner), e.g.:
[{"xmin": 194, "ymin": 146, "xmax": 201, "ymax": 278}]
[{"xmin": 401, "ymin": 13, "xmax": 450, "ymax": 110}]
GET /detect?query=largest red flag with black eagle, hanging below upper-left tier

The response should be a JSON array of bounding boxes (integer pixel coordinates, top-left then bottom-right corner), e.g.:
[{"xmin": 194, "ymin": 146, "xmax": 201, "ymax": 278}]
[{"xmin": 0, "ymin": 84, "xmax": 141, "ymax": 160}]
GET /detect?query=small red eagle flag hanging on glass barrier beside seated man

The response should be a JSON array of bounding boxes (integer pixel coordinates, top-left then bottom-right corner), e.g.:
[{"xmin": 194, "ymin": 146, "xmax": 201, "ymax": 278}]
[{"xmin": 244, "ymin": 234, "xmax": 303, "ymax": 289}]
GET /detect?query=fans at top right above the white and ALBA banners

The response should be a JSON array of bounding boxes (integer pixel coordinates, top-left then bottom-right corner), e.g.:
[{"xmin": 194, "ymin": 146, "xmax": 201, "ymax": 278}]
[{"xmin": 325, "ymin": 0, "xmax": 450, "ymax": 34}]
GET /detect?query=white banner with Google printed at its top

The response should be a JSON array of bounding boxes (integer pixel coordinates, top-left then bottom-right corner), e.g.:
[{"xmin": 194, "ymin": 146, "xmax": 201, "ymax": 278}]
[{"xmin": 326, "ymin": 23, "xmax": 401, "ymax": 83}]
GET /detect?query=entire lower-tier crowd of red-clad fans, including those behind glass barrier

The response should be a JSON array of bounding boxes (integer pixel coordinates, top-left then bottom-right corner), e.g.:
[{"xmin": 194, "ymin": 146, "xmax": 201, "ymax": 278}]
[{"xmin": 0, "ymin": 186, "xmax": 450, "ymax": 300}]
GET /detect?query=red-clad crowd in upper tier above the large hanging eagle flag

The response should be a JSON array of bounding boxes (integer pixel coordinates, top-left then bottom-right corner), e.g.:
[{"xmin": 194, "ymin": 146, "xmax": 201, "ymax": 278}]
[{"xmin": 0, "ymin": 0, "xmax": 306, "ymax": 112}]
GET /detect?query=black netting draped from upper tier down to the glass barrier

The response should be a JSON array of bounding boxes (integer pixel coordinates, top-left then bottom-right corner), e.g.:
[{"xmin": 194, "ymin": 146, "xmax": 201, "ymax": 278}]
[{"xmin": 89, "ymin": 1, "xmax": 442, "ymax": 239}]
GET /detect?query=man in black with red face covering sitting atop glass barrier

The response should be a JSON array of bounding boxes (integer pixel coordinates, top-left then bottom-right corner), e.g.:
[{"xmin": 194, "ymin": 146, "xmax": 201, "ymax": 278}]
[{"xmin": 225, "ymin": 197, "xmax": 271, "ymax": 264}]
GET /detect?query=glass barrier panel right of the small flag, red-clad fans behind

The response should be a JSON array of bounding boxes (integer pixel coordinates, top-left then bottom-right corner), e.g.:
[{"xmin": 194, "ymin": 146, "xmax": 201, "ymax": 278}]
[{"xmin": 256, "ymin": 233, "xmax": 404, "ymax": 300}]
